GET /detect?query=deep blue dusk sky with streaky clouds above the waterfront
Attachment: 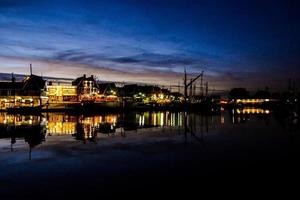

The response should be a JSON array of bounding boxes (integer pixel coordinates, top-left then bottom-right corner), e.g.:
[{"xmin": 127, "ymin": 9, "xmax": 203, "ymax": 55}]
[{"xmin": 0, "ymin": 0, "xmax": 300, "ymax": 90}]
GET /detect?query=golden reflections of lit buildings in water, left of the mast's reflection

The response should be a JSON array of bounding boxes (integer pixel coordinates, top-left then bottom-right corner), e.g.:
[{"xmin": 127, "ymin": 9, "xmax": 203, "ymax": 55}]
[{"xmin": 0, "ymin": 111, "xmax": 195, "ymax": 147}]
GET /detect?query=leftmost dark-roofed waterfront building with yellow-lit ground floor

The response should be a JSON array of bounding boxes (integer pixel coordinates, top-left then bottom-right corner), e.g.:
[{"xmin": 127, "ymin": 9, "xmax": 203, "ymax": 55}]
[{"xmin": 0, "ymin": 75, "xmax": 45, "ymax": 109}]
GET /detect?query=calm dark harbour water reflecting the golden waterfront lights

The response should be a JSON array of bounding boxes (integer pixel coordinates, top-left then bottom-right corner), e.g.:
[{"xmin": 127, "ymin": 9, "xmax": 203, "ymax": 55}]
[{"xmin": 0, "ymin": 108, "xmax": 300, "ymax": 199}]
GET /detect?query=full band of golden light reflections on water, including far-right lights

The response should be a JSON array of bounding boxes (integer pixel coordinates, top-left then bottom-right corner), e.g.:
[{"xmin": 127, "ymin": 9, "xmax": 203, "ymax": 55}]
[{"xmin": 0, "ymin": 108, "xmax": 296, "ymax": 155}]
